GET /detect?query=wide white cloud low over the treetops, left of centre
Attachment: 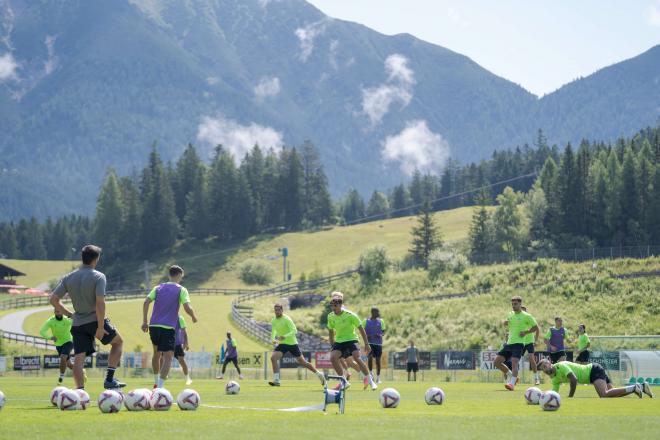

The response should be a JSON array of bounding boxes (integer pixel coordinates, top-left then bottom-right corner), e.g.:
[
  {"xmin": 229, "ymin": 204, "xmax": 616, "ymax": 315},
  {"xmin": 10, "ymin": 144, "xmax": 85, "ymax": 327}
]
[{"xmin": 197, "ymin": 116, "xmax": 284, "ymax": 161}]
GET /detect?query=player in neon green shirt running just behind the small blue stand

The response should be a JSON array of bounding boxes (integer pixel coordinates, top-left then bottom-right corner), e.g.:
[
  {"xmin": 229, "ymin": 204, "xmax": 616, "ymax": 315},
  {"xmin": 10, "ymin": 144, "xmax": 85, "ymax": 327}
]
[{"xmin": 328, "ymin": 292, "xmax": 378, "ymax": 390}]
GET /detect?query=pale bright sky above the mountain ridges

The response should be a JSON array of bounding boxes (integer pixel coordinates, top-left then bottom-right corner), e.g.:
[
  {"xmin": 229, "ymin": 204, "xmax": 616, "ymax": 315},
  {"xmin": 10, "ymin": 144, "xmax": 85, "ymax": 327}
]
[{"xmin": 308, "ymin": 0, "xmax": 660, "ymax": 95}]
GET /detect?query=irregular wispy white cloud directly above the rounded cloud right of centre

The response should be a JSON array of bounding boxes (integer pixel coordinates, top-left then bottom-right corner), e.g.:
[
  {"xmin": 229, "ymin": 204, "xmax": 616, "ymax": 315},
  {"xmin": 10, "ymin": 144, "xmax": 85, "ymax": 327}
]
[{"xmin": 362, "ymin": 54, "xmax": 415, "ymax": 126}]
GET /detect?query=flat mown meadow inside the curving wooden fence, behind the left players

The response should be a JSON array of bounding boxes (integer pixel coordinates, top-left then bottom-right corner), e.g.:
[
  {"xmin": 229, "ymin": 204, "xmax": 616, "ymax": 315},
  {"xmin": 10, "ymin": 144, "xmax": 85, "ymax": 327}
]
[{"xmin": 23, "ymin": 295, "xmax": 265, "ymax": 351}]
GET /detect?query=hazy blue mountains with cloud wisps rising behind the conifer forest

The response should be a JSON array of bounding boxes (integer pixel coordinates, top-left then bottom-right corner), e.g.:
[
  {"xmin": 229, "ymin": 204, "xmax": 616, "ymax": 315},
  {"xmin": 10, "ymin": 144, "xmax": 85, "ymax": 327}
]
[{"xmin": 0, "ymin": 0, "xmax": 660, "ymax": 220}]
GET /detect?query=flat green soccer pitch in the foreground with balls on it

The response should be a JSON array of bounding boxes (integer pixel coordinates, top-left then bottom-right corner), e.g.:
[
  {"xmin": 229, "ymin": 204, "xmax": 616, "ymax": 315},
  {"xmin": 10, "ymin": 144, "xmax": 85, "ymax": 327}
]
[{"xmin": 0, "ymin": 377, "xmax": 660, "ymax": 440}]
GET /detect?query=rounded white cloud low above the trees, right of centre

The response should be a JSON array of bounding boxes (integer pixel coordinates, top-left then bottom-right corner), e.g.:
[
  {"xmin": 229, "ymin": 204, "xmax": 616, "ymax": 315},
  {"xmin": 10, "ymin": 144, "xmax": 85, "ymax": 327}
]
[{"xmin": 381, "ymin": 120, "xmax": 449, "ymax": 175}]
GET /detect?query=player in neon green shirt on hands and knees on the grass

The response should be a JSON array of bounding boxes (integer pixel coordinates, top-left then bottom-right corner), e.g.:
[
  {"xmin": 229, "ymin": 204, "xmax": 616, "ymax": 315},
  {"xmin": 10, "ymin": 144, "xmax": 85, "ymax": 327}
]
[{"xmin": 539, "ymin": 359, "xmax": 653, "ymax": 399}]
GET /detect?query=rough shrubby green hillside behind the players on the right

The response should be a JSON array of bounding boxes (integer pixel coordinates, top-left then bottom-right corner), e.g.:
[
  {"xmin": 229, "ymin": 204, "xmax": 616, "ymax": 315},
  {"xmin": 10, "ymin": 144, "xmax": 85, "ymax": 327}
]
[{"xmin": 254, "ymin": 258, "xmax": 660, "ymax": 350}]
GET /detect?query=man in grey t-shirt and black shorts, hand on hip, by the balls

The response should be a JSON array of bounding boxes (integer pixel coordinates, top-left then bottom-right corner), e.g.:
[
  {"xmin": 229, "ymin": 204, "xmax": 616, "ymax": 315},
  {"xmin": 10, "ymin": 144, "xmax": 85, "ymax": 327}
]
[{"xmin": 50, "ymin": 245, "xmax": 126, "ymax": 389}]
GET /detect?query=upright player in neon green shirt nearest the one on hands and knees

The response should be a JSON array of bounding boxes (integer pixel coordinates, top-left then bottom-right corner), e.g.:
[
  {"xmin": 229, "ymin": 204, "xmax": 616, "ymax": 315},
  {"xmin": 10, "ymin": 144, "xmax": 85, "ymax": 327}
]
[{"xmin": 495, "ymin": 296, "xmax": 538, "ymax": 391}]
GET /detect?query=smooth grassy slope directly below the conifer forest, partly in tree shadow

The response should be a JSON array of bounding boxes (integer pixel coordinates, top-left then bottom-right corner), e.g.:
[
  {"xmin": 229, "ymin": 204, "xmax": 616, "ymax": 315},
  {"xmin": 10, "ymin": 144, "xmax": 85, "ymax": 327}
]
[{"xmin": 125, "ymin": 207, "xmax": 480, "ymax": 288}]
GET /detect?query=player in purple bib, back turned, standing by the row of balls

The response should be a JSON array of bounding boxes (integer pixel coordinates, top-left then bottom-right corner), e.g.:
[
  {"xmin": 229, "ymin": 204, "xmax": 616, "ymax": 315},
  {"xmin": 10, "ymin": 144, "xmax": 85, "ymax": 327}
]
[{"xmin": 142, "ymin": 266, "xmax": 197, "ymax": 388}]
